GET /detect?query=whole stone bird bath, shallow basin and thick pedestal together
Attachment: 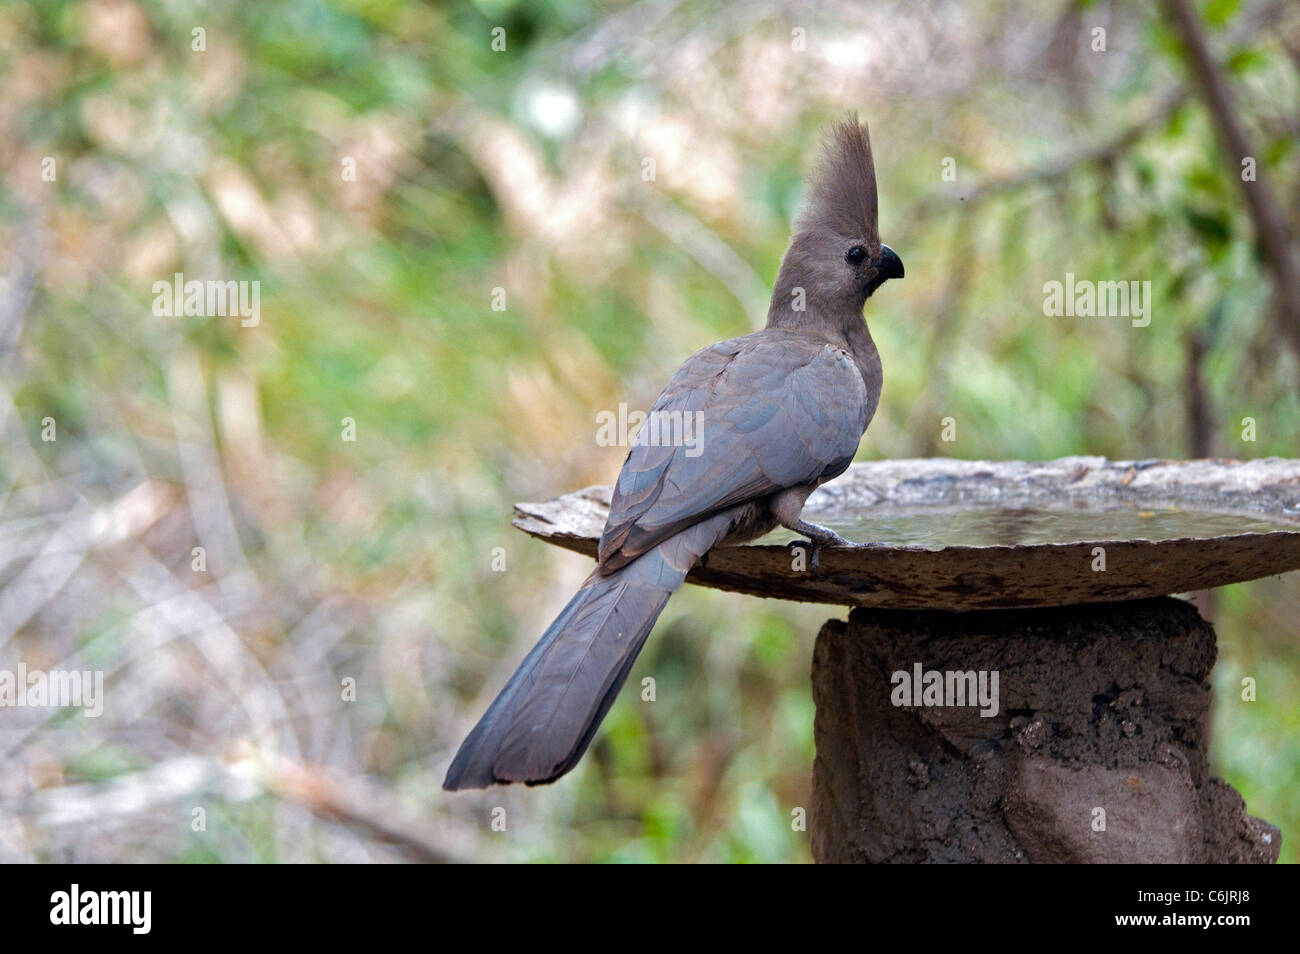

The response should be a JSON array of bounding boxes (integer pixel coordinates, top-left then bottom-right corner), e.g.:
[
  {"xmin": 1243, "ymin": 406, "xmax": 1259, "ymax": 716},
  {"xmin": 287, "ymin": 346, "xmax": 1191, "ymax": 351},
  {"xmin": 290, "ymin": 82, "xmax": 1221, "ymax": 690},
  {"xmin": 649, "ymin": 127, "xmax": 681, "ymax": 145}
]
[{"xmin": 515, "ymin": 458, "xmax": 1300, "ymax": 862}]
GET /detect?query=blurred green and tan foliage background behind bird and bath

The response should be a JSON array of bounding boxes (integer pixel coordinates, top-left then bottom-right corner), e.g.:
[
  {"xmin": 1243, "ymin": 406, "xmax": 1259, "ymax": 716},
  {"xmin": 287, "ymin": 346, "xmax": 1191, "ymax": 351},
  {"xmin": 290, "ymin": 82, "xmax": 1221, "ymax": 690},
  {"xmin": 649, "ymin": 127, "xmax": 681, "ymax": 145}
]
[{"xmin": 0, "ymin": 0, "xmax": 1300, "ymax": 862}]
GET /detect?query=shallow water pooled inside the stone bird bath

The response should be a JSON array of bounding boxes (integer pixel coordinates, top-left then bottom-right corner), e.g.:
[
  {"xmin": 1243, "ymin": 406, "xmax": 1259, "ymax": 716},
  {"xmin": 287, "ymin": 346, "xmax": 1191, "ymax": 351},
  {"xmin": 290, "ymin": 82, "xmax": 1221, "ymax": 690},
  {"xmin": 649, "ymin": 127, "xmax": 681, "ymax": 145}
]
[{"xmin": 762, "ymin": 506, "xmax": 1300, "ymax": 550}]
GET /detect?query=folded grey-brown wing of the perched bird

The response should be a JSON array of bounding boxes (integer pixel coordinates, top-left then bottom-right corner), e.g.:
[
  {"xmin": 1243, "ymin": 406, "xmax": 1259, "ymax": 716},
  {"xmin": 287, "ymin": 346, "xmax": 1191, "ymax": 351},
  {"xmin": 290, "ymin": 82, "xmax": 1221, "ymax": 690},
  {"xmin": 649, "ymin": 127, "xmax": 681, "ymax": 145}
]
[{"xmin": 599, "ymin": 329, "xmax": 867, "ymax": 565}]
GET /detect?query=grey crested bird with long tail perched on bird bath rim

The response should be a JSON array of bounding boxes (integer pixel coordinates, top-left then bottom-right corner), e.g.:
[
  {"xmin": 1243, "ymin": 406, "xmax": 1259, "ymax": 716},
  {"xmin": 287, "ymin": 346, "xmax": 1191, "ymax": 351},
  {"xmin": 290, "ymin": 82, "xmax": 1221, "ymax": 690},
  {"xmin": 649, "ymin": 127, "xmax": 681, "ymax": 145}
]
[{"xmin": 443, "ymin": 113, "xmax": 904, "ymax": 790}]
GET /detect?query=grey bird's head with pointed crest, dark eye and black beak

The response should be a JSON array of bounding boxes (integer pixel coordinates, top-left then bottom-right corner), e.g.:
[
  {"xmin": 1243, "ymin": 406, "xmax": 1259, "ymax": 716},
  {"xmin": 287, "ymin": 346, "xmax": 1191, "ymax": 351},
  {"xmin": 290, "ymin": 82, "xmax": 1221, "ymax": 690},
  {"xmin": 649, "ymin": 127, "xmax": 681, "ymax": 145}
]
[{"xmin": 772, "ymin": 113, "xmax": 904, "ymax": 317}]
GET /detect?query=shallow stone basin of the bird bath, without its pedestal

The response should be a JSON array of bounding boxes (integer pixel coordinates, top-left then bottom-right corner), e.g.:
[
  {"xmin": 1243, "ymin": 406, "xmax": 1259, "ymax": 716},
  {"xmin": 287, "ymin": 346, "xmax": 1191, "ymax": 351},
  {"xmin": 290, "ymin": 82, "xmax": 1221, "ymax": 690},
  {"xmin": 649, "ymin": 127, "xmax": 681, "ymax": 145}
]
[{"xmin": 515, "ymin": 458, "xmax": 1300, "ymax": 610}]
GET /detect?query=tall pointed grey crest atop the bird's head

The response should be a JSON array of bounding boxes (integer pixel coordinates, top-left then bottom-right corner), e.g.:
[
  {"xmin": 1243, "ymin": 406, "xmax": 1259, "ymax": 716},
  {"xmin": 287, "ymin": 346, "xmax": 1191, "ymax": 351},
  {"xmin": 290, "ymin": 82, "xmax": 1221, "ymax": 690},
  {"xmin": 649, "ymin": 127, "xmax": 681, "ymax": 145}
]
[{"xmin": 796, "ymin": 112, "xmax": 880, "ymax": 255}]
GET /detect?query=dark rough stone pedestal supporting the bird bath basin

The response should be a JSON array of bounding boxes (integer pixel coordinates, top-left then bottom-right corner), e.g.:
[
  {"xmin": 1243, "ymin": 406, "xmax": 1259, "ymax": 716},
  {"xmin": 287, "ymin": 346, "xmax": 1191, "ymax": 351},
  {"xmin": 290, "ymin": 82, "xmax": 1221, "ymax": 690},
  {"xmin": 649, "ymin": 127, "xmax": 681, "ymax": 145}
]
[{"xmin": 810, "ymin": 598, "xmax": 1282, "ymax": 863}]
